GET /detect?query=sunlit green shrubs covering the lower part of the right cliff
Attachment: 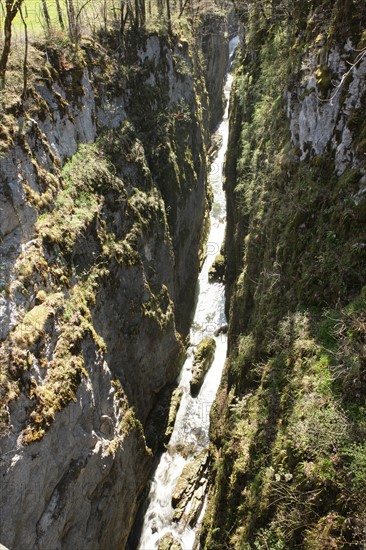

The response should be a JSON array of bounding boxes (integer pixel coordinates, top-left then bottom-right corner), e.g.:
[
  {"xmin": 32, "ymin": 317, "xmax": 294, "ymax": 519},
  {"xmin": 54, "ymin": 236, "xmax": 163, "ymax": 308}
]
[{"xmin": 203, "ymin": 298, "xmax": 366, "ymax": 548}]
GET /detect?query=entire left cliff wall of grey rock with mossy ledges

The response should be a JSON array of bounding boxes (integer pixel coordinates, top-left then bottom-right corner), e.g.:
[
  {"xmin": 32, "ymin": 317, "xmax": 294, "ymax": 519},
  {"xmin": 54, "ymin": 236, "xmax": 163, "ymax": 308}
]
[{"xmin": 0, "ymin": 20, "xmax": 226, "ymax": 550}]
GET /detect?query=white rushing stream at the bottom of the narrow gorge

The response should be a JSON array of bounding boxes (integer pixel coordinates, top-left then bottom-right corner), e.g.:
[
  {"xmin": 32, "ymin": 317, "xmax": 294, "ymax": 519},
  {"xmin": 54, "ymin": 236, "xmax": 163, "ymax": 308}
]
[{"xmin": 133, "ymin": 38, "xmax": 238, "ymax": 550}]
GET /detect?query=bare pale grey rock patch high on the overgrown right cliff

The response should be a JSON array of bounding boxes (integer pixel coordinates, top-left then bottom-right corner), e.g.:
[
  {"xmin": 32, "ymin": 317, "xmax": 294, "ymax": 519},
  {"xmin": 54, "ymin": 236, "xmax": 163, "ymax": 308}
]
[{"xmin": 287, "ymin": 37, "xmax": 366, "ymax": 176}]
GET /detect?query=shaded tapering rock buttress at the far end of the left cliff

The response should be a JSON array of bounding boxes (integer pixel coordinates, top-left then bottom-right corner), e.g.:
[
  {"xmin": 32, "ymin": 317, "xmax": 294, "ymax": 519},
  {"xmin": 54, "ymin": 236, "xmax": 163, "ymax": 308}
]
[{"xmin": 124, "ymin": 37, "xmax": 209, "ymax": 334}]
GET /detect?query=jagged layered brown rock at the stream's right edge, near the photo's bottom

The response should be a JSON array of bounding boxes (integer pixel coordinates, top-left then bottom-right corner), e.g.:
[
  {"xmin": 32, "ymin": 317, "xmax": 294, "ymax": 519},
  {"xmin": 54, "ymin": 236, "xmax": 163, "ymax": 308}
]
[{"xmin": 172, "ymin": 449, "xmax": 209, "ymax": 526}]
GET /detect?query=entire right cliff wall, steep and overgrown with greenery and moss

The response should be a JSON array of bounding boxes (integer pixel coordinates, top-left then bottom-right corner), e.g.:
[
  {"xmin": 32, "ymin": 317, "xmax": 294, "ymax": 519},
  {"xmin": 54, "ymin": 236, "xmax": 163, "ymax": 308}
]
[{"xmin": 201, "ymin": 0, "xmax": 366, "ymax": 549}]
